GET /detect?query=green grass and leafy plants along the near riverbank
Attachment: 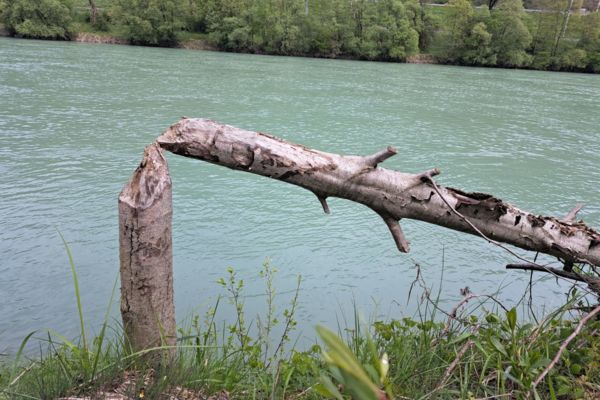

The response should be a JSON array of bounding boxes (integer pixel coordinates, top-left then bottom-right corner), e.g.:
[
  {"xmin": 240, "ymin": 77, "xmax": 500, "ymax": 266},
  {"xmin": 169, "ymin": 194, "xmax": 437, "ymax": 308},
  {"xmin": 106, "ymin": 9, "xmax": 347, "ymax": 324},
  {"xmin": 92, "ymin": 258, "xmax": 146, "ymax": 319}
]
[{"xmin": 0, "ymin": 262, "xmax": 600, "ymax": 400}]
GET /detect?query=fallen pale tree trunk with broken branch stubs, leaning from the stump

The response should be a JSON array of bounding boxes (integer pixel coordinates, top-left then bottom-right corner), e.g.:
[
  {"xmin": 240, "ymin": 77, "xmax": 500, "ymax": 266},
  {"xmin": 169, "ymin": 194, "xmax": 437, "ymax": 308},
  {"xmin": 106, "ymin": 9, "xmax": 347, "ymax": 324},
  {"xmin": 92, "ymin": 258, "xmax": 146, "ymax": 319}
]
[{"xmin": 157, "ymin": 119, "xmax": 600, "ymax": 266}]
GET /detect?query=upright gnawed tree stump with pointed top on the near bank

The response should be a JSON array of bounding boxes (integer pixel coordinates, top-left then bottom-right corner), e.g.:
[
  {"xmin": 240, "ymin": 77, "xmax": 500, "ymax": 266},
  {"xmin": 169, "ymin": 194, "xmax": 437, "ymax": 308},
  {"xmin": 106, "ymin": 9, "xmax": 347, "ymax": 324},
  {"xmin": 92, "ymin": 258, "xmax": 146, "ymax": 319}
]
[{"xmin": 119, "ymin": 144, "xmax": 176, "ymax": 356}]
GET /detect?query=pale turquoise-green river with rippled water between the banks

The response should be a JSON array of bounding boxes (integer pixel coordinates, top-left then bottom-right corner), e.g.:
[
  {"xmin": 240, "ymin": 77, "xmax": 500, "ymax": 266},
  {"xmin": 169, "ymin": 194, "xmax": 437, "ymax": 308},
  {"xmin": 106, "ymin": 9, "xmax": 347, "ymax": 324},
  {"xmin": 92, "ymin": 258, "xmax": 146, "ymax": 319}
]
[{"xmin": 0, "ymin": 38, "xmax": 600, "ymax": 353}]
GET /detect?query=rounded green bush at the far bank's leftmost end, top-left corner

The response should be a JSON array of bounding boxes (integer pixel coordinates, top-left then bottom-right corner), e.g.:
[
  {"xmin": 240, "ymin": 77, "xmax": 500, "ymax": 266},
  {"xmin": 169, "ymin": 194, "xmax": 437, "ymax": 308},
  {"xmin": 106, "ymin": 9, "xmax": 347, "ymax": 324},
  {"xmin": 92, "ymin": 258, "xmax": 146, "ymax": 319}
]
[{"xmin": 0, "ymin": 0, "xmax": 73, "ymax": 40}]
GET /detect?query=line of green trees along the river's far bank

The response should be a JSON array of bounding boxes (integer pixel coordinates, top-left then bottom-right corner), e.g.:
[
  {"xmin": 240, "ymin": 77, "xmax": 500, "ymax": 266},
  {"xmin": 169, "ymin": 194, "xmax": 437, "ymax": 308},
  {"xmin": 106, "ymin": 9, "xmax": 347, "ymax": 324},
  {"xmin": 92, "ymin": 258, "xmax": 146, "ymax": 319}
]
[{"xmin": 0, "ymin": 0, "xmax": 600, "ymax": 72}]
